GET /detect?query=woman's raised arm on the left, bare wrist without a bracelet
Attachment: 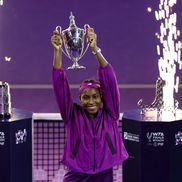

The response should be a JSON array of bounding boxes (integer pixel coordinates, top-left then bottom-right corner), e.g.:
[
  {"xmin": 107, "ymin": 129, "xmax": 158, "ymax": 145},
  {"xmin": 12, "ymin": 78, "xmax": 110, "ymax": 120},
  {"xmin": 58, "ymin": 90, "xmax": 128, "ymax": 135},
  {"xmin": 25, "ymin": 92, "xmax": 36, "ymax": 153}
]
[{"xmin": 51, "ymin": 31, "xmax": 73, "ymax": 123}]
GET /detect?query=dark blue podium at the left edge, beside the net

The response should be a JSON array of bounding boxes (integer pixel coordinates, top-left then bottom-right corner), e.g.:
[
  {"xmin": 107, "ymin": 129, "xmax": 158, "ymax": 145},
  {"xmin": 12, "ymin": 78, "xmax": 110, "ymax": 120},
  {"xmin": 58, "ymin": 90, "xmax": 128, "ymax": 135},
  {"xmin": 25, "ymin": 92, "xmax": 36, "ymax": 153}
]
[{"xmin": 0, "ymin": 109, "xmax": 32, "ymax": 182}]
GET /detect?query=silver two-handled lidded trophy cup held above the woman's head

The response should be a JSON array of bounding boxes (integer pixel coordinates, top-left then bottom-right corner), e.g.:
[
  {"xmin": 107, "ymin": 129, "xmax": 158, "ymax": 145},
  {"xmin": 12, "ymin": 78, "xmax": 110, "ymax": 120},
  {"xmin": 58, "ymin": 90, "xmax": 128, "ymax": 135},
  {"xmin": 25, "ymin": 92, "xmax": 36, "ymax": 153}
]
[{"xmin": 56, "ymin": 12, "xmax": 90, "ymax": 69}]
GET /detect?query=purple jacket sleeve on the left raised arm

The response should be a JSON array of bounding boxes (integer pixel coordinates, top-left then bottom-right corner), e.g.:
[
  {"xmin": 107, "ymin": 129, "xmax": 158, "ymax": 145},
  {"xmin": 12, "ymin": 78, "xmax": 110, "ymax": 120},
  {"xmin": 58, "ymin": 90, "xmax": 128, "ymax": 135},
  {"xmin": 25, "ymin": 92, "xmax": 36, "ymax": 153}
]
[{"xmin": 52, "ymin": 68, "xmax": 73, "ymax": 122}]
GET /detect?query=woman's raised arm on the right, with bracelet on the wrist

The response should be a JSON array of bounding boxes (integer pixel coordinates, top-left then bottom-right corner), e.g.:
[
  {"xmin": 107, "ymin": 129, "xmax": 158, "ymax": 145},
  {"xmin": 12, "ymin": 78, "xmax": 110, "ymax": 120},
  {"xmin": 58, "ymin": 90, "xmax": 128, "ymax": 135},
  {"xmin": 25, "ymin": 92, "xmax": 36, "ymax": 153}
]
[{"xmin": 88, "ymin": 28, "xmax": 120, "ymax": 119}]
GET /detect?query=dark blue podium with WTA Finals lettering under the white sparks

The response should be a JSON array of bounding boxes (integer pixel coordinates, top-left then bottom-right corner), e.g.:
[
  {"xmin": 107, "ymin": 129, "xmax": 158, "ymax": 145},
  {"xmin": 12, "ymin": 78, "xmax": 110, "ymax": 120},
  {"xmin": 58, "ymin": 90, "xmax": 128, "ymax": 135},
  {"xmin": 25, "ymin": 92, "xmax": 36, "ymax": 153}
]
[{"xmin": 122, "ymin": 110, "xmax": 182, "ymax": 182}]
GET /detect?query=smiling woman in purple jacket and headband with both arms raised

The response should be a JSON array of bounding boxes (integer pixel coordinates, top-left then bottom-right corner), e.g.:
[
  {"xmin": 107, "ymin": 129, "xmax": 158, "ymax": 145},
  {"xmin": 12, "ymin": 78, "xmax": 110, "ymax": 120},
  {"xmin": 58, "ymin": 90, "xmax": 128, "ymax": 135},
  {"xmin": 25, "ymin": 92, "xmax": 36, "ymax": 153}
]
[{"xmin": 51, "ymin": 27, "xmax": 128, "ymax": 182}]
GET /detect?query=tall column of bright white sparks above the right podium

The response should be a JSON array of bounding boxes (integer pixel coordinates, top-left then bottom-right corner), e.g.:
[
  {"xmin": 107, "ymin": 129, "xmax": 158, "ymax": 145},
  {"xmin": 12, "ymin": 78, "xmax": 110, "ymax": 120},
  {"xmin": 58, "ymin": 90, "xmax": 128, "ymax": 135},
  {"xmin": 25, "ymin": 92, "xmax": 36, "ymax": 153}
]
[{"xmin": 155, "ymin": 0, "xmax": 182, "ymax": 120}]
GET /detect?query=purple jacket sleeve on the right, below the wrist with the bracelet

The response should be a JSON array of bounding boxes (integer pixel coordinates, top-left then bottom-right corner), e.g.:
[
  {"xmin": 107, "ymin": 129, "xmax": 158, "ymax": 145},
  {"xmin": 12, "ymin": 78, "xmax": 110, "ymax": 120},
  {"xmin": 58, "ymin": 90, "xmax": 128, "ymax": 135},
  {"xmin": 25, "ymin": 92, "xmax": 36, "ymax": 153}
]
[{"xmin": 98, "ymin": 64, "xmax": 120, "ymax": 119}]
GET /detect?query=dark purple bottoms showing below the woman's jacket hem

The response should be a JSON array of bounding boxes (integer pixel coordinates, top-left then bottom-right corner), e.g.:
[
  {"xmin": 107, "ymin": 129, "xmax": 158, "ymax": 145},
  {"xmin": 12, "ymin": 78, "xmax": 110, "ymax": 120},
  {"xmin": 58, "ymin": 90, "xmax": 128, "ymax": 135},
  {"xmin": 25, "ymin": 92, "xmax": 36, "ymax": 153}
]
[{"xmin": 63, "ymin": 168, "xmax": 113, "ymax": 182}]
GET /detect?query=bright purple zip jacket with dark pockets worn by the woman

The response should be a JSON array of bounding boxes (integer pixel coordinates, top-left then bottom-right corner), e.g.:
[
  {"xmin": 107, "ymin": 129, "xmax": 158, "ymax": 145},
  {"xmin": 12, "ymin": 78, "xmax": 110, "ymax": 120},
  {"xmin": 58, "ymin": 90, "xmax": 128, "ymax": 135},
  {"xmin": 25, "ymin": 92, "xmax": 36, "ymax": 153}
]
[{"xmin": 53, "ymin": 64, "xmax": 128, "ymax": 174}]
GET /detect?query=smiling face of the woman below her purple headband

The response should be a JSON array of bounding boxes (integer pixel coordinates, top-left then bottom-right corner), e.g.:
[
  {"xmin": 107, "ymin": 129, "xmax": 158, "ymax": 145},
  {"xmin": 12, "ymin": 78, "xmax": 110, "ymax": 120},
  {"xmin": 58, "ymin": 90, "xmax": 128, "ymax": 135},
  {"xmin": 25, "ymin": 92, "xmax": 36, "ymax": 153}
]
[{"xmin": 80, "ymin": 88, "xmax": 102, "ymax": 117}]
